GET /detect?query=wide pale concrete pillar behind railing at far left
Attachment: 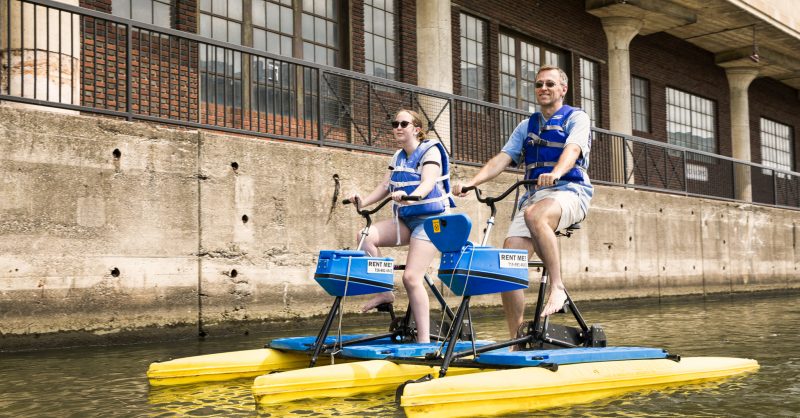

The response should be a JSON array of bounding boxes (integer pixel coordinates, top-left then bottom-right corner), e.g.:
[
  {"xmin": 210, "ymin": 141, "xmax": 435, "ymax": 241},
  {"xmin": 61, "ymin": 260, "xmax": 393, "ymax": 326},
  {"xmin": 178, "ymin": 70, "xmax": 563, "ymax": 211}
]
[{"xmin": 0, "ymin": 0, "xmax": 81, "ymax": 113}]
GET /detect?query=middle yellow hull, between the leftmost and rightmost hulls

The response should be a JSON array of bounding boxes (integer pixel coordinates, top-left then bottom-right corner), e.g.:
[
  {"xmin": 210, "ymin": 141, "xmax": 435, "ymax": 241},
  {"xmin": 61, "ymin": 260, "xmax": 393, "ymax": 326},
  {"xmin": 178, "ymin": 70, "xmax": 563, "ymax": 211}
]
[{"xmin": 253, "ymin": 360, "xmax": 482, "ymax": 406}]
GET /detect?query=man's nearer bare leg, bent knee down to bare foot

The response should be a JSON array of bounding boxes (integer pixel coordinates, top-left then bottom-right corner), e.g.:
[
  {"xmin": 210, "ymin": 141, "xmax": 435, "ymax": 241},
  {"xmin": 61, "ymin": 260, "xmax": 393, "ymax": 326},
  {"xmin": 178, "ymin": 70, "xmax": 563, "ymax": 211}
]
[{"xmin": 525, "ymin": 199, "xmax": 567, "ymax": 317}]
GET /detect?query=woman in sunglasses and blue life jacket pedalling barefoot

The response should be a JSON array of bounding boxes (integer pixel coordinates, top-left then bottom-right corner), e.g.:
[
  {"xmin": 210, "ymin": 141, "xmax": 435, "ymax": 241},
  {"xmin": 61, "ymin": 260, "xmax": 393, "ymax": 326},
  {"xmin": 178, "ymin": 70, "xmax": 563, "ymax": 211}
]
[{"xmin": 351, "ymin": 109, "xmax": 455, "ymax": 343}]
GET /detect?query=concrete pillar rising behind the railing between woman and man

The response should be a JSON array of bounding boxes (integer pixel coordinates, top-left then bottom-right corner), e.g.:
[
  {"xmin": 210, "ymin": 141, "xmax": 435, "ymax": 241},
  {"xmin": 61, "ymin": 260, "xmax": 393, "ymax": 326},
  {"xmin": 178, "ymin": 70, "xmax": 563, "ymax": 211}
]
[{"xmin": 417, "ymin": 0, "xmax": 453, "ymax": 150}]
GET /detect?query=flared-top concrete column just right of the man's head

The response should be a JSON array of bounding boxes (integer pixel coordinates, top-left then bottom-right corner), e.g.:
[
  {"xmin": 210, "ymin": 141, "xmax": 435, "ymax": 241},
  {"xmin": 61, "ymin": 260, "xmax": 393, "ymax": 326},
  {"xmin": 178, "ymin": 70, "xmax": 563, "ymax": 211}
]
[{"xmin": 601, "ymin": 16, "xmax": 644, "ymax": 183}]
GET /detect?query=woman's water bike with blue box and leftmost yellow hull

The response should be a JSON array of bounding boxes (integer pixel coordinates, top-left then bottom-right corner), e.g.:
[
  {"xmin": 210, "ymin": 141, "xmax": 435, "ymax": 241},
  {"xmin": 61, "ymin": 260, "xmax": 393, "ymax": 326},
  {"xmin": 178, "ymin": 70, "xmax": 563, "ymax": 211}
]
[{"xmin": 147, "ymin": 196, "xmax": 482, "ymax": 386}]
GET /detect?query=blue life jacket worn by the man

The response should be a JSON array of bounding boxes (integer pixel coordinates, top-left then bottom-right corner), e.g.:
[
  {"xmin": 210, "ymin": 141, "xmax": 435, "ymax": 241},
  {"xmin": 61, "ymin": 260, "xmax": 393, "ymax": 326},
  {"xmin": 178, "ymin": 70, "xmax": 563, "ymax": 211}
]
[{"xmin": 523, "ymin": 105, "xmax": 592, "ymax": 183}]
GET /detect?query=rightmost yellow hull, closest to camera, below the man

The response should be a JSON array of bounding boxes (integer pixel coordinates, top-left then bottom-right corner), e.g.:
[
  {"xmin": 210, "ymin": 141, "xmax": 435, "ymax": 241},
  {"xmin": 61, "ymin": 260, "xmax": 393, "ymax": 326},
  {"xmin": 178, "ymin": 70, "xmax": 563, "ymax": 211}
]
[{"xmin": 400, "ymin": 357, "xmax": 759, "ymax": 418}]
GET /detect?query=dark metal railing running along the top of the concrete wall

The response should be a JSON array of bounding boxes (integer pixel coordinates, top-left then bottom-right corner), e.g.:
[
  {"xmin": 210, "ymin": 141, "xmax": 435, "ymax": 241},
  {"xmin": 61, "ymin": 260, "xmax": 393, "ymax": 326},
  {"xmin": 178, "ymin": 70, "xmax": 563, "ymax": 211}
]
[{"xmin": 0, "ymin": 0, "xmax": 800, "ymax": 209}]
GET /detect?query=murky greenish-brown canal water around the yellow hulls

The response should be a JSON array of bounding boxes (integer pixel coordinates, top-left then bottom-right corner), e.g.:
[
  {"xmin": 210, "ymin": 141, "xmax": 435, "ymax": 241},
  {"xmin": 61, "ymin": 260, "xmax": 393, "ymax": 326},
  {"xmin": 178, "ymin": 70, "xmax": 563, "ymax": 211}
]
[{"xmin": 0, "ymin": 292, "xmax": 800, "ymax": 417}]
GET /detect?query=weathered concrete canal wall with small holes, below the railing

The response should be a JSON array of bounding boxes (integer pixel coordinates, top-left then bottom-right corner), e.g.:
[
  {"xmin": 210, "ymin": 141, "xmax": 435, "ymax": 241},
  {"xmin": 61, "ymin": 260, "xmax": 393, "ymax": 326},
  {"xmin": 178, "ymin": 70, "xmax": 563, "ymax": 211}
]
[{"xmin": 0, "ymin": 107, "xmax": 800, "ymax": 350}]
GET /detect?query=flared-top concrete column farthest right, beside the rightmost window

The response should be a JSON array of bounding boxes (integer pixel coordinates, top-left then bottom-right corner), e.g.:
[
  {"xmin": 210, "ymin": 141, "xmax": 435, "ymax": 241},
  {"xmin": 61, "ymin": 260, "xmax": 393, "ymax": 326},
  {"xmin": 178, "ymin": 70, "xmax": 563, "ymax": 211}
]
[{"xmin": 725, "ymin": 67, "xmax": 758, "ymax": 202}]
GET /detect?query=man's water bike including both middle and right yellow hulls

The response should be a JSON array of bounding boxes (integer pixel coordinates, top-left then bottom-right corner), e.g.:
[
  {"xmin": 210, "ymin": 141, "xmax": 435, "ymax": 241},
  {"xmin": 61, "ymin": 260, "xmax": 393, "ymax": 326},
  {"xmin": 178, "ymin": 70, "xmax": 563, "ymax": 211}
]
[{"xmin": 253, "ymin": 181, "xmax": 758, "ymax": 416}]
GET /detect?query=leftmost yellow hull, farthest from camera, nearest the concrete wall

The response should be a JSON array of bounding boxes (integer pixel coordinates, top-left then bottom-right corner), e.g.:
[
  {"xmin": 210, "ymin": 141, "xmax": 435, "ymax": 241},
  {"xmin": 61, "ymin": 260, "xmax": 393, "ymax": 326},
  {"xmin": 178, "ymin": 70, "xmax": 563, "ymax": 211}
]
[{"xmin": 147, "ymin": 348, "xmax": 310, "ymax": 386}]
